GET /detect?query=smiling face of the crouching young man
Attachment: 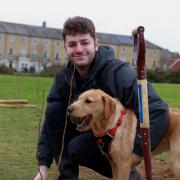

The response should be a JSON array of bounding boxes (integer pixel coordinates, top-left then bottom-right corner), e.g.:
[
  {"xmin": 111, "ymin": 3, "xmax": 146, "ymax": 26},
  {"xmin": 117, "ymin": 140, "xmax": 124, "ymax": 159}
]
[{"xmin": 65, "ymin": 34, "xmax": 99, "ymax": 69}]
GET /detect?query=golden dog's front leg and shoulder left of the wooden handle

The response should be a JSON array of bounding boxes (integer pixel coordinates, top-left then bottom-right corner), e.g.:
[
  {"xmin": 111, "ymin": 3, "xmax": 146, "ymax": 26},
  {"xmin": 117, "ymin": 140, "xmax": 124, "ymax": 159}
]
[{"xmin": 110, "ymin": 111, "xmax": 137, "ymax": 180}]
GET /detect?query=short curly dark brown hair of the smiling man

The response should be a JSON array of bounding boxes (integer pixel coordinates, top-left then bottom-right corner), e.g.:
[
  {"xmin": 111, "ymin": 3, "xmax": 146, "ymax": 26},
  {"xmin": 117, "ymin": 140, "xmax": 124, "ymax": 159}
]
[{"xmin": 62, "ymin": 16, "xmax": 96, "ymax": 41}]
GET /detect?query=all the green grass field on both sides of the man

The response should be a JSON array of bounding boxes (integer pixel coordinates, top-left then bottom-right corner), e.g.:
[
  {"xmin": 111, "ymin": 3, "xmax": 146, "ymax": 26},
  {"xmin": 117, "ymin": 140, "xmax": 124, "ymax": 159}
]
[{"xmin": 0, "ymin": 75, "xmax": 180, "ymax": 180}]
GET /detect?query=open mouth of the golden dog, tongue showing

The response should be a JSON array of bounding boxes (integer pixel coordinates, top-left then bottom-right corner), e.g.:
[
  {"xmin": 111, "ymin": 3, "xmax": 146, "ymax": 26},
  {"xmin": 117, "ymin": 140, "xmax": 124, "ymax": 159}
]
[{"xmin": 71, "ymin": 115, "xmax": 92, "ymax": 130}]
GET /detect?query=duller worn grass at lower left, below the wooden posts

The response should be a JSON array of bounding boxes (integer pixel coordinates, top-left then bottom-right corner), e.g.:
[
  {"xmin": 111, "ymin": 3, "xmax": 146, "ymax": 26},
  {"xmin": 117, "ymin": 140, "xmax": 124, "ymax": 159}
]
[{"xmin": 0, "ymin": 109, "xmax": 38, "ymax": 180}]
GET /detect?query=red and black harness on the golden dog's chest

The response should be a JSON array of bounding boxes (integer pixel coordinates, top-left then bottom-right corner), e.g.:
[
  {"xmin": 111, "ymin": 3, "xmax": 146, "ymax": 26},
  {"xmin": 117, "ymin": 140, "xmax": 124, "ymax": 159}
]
[{"xmin": 94, "ymin": 111, "xmax": 126, "ymax": 158}]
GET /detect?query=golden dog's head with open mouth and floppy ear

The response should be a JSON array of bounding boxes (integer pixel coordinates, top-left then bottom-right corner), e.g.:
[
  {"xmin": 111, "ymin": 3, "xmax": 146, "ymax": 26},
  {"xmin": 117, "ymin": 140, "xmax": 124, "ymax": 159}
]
[{"xmin": 68, "ymin": 89, "xmax": 116, "ymax": 132}]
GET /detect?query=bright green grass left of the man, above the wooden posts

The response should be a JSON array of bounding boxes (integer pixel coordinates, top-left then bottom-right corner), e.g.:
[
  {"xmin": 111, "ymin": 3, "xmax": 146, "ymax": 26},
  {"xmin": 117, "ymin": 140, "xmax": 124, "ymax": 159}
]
[{"xmin": 0, "ymin": 75, "xmax": 53, "ymax": 105}]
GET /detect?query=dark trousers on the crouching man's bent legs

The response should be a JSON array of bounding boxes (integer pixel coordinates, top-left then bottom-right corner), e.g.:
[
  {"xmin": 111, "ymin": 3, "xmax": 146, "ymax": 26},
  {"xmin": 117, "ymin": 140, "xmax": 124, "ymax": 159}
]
[{"xmin": 58, "ymin": 132, "xmax": 112, "ymax": 180}]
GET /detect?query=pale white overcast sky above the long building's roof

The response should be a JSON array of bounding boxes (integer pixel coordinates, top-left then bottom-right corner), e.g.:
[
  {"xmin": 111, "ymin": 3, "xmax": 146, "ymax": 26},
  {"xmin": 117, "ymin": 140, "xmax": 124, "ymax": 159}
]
[{"xmin": 0, "ymin": 0, "xmax": 180, "ymax": 52}]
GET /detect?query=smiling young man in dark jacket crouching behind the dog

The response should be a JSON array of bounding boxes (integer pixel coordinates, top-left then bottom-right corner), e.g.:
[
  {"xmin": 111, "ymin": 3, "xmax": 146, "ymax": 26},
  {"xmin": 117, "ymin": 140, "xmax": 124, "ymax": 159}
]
[{"xmin": 35, "ymin": 16, "xmax": 168, "ymax": 180}]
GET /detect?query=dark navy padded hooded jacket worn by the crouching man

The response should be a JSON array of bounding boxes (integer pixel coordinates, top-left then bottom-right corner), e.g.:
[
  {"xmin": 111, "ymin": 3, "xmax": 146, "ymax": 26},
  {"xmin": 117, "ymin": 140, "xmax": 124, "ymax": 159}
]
[{"xmin": 38, "ymin": 46, "xmax": 168, "ymax": 167}]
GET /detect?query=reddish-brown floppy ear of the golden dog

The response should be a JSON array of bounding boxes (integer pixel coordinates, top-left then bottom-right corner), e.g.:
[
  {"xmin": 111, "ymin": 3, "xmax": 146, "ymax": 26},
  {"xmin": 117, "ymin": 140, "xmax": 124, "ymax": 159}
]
[{"xmin": 102, "ymin": 95, "xmax": 116, "ymax": 119}]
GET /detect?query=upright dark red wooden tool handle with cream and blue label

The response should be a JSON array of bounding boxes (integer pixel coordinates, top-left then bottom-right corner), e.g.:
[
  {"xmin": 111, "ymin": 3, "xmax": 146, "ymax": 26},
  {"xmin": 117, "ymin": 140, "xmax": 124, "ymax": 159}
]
[{"xmin": 133, "ymin": 26, "xmax": 152, "ymax": 180}]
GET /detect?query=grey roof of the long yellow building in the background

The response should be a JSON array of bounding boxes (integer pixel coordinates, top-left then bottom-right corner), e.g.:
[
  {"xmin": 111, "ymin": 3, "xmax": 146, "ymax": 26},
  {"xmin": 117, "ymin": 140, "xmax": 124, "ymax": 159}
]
[{"xmin": 0, "ymin": 21, "xmax": 161, "ymax": 49}]
